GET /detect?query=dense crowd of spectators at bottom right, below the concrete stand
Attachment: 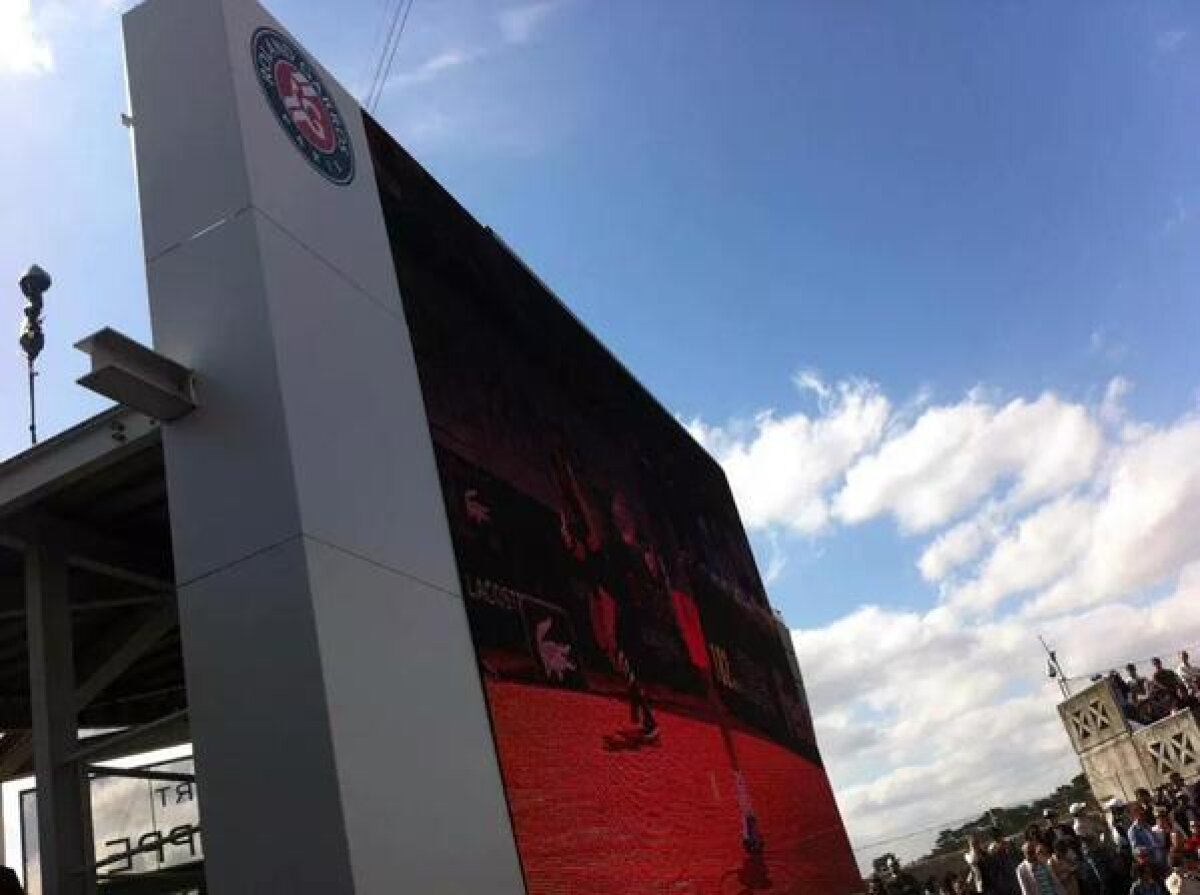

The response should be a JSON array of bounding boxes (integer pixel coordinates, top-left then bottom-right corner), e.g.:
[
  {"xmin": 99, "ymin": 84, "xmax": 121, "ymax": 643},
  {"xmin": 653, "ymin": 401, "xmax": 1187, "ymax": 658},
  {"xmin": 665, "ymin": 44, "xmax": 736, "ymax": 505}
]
[{"xmin": 868, "ymin": 774, "xmax": 1200, "ymax": 895}]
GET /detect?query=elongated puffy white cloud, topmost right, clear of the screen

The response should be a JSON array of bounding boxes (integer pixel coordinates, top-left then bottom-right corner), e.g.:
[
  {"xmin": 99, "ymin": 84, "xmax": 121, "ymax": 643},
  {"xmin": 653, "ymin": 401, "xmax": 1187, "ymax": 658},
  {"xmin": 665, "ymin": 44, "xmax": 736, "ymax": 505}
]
[{"xmin": 834, "ymin": 394, "xmax": 1103, "ymax": 531}]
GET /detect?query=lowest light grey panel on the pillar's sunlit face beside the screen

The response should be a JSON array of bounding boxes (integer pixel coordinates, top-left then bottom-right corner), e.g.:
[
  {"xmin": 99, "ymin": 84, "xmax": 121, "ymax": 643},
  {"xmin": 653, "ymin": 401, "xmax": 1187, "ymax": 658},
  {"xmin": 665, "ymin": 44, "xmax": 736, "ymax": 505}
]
[{"xmin": 306, "ymin": 540, "xmax": 524, "ymax": 895}]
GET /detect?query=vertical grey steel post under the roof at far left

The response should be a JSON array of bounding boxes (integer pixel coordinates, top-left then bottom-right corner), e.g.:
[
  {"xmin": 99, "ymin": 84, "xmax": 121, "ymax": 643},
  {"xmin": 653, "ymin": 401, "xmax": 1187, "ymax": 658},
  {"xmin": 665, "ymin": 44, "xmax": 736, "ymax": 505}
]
[{"xmin": 25, "ymin": 541, "xmax": 96, "ymax": 895}]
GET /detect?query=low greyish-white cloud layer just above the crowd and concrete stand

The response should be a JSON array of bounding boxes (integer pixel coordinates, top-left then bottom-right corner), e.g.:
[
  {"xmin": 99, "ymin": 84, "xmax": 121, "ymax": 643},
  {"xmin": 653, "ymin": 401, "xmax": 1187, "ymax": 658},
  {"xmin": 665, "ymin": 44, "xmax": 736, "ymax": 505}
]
[{"xmin": 793, "ymin": 564, "xmax": 1200, "ymax": 859}]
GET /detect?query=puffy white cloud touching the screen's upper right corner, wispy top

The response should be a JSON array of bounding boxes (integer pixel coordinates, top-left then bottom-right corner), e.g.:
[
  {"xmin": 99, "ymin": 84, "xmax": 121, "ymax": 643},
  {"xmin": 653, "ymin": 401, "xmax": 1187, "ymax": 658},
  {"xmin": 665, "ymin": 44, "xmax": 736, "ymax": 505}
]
[{"xmin": 689, "ymin": 374, "xmax": 890, "ymax": 534}]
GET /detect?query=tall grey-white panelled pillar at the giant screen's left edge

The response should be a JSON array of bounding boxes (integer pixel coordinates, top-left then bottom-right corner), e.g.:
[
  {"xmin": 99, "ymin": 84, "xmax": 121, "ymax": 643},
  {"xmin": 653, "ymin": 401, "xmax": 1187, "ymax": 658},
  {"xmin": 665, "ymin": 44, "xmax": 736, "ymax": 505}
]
[{"xmin": 125, "ymin": 0, "xmax": 523, "ymax": 895}]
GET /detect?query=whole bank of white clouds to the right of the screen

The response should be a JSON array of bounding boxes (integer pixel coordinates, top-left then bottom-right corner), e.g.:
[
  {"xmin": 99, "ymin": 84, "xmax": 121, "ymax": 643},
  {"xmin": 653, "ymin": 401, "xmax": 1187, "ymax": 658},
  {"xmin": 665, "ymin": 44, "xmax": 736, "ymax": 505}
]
[{"xmin": 692, "ymin": 373, "xmax": 1200, "ymax": 859}]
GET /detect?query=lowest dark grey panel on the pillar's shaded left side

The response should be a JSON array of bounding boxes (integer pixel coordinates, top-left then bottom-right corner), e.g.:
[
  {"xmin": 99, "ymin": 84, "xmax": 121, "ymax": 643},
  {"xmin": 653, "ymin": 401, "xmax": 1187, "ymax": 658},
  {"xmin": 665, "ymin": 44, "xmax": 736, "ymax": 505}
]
[{"xmin": 179, "ymin": 537, "xmax": 352, "ymax": 895}]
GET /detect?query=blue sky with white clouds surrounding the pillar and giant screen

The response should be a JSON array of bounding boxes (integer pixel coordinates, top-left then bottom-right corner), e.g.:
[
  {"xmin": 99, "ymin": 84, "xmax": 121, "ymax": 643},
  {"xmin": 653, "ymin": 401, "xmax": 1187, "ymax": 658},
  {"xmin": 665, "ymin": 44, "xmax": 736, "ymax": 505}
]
[{"xmin": 0, "ymin": 0, "xmax": 1200, "ymax": 859}]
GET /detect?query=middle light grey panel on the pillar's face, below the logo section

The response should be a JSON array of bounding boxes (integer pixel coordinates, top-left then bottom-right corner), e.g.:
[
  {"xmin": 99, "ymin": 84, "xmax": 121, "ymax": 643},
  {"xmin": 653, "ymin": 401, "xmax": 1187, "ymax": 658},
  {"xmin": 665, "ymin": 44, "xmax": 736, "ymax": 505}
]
[{"xmin": 257, "ymin": 216, "xmax": 460, "ymax": 593}]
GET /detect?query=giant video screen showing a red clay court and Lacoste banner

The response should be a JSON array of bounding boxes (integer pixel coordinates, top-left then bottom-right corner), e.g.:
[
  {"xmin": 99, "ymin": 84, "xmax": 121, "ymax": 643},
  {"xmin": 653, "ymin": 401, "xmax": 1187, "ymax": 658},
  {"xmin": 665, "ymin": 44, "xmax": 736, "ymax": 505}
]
[{"xmin": 366, "ymin": 118, "xmax": 860, "ymax": 895}]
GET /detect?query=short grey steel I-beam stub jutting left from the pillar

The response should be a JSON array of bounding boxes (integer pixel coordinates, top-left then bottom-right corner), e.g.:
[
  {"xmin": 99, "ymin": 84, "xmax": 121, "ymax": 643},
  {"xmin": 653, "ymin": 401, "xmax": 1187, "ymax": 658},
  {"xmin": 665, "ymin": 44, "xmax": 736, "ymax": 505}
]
[{"xmin": 76, "ymin": 326, "xmax": 197, "ymax": 421}]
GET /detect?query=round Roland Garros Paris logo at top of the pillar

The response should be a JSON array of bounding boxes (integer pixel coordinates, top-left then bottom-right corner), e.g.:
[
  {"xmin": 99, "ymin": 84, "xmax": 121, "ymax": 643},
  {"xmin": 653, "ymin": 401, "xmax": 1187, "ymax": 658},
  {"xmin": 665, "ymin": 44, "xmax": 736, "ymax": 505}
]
[{"xmin": 251, "ymin": 28, "xmax": 354, "ymax": 186}]
